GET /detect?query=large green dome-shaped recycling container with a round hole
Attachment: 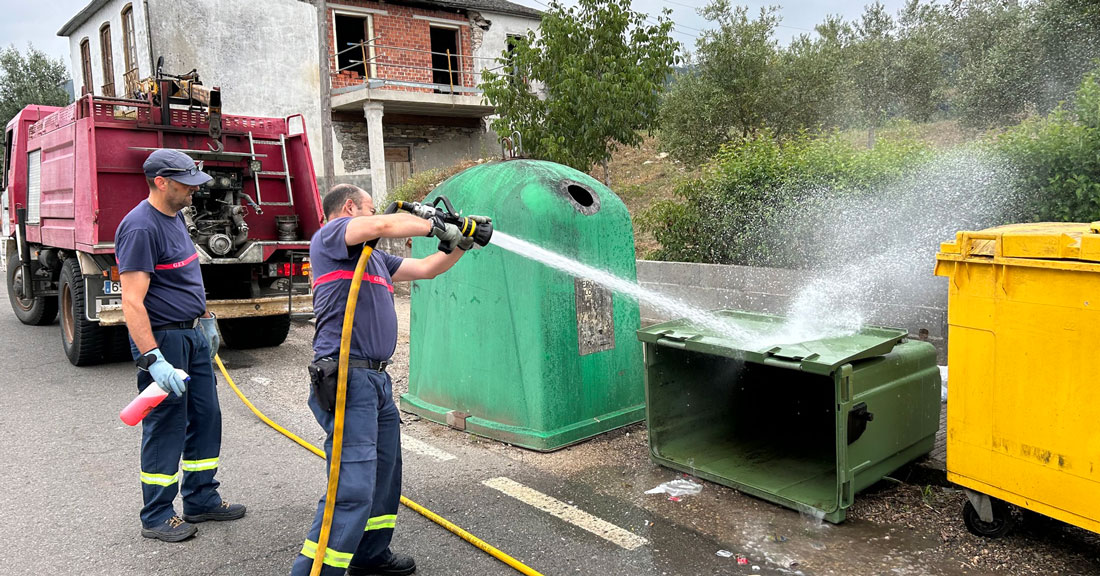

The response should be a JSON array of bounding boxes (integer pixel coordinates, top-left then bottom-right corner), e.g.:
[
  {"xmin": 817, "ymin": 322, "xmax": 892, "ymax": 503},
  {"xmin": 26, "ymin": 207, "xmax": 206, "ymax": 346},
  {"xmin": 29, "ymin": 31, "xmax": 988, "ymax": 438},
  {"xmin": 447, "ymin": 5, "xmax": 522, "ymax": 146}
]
[{"xmin": 400, "ymin": 159, "xmax": 645, "ymax": 451}]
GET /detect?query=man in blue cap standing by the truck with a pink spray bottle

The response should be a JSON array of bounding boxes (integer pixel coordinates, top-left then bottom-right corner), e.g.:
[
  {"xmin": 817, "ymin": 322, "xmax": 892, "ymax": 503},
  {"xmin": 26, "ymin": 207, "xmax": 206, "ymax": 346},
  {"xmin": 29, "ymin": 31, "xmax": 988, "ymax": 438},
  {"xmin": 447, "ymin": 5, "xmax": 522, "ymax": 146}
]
[{"xmin": 114, "ymin": 149, "xmax": 244, "ymax": 542}]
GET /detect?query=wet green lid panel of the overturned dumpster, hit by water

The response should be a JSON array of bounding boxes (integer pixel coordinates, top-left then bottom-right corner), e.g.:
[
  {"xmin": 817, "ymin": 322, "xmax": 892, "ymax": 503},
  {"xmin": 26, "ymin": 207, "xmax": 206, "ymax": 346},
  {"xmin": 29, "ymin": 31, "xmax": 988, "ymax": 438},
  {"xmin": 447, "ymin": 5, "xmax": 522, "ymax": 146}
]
[{"xmin": 638, "ymin": 310, "xmax": 909, "ymax": 375}]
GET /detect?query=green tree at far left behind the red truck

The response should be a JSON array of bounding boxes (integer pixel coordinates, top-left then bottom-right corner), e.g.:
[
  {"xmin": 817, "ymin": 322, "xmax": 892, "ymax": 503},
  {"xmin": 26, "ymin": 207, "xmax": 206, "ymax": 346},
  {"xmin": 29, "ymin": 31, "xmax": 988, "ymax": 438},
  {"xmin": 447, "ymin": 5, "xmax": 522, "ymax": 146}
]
[{"xmin": 0, "ymin": 45, "xmax": 72, "ymax": 126}]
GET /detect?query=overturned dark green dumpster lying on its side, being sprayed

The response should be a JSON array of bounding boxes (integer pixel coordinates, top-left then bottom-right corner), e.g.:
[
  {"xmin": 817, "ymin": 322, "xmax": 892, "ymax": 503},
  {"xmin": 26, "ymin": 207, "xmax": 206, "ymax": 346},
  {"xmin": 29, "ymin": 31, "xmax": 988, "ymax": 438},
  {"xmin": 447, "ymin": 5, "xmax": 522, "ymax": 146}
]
[{"xmin": 638, "ymin": 311, "xmax": 941, "ymax": 523}]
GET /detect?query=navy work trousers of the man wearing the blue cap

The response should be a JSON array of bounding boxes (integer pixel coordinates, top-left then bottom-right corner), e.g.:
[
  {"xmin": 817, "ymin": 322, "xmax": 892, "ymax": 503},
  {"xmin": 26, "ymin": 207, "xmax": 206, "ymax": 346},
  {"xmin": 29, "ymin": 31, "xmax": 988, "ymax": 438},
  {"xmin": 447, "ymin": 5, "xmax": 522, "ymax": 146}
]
[{"xmin": 130, "ymin": 326, "xmax": 221, "ymax": 528}]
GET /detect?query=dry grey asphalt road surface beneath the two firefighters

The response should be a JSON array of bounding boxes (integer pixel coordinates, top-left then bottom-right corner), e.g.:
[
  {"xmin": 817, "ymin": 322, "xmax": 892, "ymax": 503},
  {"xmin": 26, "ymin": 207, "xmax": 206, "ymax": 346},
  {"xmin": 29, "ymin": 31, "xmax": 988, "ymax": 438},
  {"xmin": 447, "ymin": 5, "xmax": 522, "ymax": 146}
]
[{"xmin": 0, "ymin": 275, "xmax": 800, "ymax": 576}]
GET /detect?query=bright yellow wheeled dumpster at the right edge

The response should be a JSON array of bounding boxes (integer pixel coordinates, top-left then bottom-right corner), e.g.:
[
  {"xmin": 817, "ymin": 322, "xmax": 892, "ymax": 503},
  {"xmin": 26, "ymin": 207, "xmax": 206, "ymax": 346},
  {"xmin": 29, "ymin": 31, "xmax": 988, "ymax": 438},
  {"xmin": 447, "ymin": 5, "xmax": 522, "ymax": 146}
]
[{"xmin": 936, "ymin": 222, "xmax": 1100, "ymax": 536}]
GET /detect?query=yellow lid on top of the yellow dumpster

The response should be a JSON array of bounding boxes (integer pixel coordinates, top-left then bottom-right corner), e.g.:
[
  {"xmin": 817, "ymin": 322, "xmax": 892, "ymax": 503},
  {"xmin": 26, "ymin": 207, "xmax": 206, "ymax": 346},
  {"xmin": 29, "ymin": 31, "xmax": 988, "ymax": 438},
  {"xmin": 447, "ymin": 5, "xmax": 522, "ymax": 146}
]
[{"xmin": 939, "ymin": 222, "xmax": 1100, "ymax": 262}]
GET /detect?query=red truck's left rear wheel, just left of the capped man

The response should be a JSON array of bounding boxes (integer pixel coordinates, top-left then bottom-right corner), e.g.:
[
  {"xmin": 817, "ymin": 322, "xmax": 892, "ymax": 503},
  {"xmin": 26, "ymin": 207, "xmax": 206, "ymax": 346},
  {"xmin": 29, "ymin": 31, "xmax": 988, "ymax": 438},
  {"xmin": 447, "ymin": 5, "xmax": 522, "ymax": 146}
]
[{"xmin": 57, "ymin": 258, "xmax": 112, "ymax": 366}]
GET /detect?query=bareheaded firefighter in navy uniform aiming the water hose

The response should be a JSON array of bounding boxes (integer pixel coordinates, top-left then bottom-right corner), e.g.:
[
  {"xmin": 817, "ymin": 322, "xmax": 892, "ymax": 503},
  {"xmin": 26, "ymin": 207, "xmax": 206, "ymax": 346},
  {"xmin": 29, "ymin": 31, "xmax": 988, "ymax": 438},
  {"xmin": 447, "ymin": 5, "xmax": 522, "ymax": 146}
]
[{"xmin": 292, "ymin": 185, "xmax": 473, "ymax": 576}]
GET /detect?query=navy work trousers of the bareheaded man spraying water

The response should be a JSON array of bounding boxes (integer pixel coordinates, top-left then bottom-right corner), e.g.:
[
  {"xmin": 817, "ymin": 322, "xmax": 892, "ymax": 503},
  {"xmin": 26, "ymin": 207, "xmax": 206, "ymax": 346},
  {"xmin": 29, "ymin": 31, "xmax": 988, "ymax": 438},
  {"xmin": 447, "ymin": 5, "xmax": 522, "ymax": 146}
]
[{"xmin": 290, "ymin": 368, "xmax": 402, "ymax": 576}]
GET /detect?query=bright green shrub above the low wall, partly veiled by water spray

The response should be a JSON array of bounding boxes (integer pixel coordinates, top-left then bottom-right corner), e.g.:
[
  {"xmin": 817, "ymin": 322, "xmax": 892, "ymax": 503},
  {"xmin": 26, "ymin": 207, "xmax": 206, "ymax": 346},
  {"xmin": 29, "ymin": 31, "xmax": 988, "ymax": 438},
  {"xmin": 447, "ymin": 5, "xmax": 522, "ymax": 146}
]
[{"xmin": 640, "ymin": 131, "xmax": 933, "ymax": 267}]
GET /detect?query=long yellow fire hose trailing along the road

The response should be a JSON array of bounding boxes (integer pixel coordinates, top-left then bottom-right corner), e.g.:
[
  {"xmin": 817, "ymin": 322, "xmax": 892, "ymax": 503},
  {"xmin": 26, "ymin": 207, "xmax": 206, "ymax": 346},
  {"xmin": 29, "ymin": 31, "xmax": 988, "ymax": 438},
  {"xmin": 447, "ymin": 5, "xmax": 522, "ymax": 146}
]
[{"xmin": 213, "ymin": 242, "xmax": 542, "ymax": 576}]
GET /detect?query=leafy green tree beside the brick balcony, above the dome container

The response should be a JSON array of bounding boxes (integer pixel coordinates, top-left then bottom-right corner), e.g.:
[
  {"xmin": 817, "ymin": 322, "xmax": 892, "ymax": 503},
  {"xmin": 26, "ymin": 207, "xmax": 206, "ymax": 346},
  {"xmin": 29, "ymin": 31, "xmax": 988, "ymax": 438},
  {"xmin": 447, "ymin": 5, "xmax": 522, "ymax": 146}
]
[{"xmin": 481, "ymin": 0, "xmax": 680, "ymax": 179}]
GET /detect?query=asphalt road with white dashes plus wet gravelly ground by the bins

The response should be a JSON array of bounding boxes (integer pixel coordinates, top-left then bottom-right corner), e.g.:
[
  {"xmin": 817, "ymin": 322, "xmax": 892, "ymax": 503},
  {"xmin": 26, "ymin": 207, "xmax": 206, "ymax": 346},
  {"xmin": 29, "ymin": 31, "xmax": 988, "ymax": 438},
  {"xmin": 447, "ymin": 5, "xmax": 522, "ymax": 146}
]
[{"xmin": 0, "ymin": 271, "xmax": 1097, "ymax": 576}]
